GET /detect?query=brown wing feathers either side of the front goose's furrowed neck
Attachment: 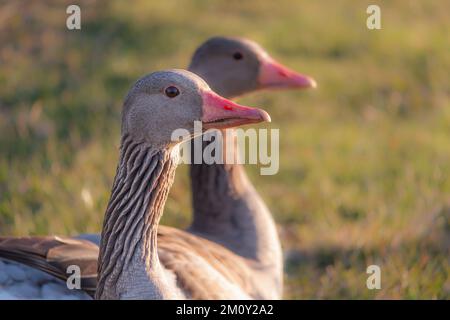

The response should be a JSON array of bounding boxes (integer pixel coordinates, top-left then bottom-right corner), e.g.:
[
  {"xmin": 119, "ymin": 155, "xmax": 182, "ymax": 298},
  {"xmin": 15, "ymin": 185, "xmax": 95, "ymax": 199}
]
[{"xmin": 0, "ymin": 226, "xmax": 253, "ymax": 299}]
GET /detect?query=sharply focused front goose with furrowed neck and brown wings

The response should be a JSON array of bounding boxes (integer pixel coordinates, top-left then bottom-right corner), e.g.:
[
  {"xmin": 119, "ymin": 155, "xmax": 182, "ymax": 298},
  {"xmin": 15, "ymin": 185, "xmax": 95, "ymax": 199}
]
[{"xmin": 0, "ymin": 70, "xmax": 270, "ymax": 299}]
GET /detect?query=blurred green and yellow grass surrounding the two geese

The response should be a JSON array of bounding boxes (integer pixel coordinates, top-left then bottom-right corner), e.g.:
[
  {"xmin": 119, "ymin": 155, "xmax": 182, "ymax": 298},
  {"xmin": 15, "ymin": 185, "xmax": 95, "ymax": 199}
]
[{"xmin": 0, "ymin": 0, "xmax": 450, "ymax": 299}]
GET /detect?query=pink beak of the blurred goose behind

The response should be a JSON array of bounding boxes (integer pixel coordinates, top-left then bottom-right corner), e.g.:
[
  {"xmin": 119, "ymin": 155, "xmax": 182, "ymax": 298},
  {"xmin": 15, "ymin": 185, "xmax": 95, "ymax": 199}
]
[{"xmin": 258, "ymin": 56, "xmax": 317, "ymax": 89}]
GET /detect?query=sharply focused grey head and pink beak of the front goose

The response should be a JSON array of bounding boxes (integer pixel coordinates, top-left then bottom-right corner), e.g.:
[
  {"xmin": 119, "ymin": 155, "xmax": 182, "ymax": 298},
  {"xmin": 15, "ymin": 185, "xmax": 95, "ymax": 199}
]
[{"xmin": 122, "ymin": 69, "xmax": 270, "ymax": 147}]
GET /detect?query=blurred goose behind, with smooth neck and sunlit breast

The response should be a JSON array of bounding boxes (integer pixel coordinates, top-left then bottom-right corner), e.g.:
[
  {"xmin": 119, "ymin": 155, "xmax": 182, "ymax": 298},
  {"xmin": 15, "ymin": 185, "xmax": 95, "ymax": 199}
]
[{"xmin": 188, "ymin": 37, "xmax": 317, "ymax": 299}]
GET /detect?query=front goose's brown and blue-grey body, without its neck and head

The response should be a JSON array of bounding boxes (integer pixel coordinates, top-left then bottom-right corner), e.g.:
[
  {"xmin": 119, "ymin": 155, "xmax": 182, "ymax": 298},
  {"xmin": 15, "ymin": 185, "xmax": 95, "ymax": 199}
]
[{"xmin": 0, "ymin": 226, "xmax": 269, "ymax": 299}]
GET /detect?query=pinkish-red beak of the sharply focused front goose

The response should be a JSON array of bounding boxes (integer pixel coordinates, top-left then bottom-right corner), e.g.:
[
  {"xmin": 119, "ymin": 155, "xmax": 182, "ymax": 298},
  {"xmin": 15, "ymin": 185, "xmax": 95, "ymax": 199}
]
[{"xmin": 201, "ymin": 91, "xmax": 271, "ymax": 129}]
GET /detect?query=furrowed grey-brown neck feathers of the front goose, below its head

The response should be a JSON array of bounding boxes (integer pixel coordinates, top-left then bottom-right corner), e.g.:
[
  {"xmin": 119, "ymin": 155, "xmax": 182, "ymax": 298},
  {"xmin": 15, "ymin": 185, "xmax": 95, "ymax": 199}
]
[{"xmin": 96, "ymin": 136, "xmax": 177, "ymax": 298}]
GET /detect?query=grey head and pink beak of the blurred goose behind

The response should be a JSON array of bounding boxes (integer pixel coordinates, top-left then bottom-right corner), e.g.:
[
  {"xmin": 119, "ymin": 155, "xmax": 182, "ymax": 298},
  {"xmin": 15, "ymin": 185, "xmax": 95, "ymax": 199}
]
[{"xmin": 189, "ymin": 37, "xmax": 316, "ymax": 97}]
